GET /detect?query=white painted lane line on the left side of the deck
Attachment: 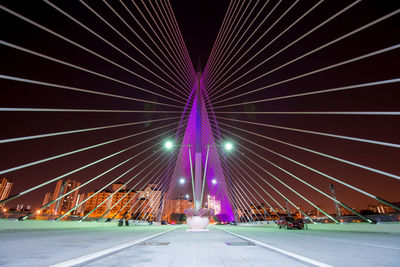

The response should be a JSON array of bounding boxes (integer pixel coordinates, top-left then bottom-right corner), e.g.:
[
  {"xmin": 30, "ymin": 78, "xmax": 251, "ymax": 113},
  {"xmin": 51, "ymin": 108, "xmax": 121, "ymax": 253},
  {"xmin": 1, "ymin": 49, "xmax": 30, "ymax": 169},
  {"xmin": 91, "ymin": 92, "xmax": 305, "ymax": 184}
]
[{"xmin": 50, "ymin": 228, "xmax": 177, "ymax": 267}]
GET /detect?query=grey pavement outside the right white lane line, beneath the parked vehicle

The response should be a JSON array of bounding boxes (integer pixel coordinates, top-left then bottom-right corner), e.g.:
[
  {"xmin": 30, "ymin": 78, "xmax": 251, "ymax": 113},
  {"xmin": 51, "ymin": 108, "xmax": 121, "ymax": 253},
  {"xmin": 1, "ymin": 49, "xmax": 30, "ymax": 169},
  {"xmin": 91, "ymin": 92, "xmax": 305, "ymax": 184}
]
[{"xmin": 221, "ymin": 226, "xmax": 400, "ymax": 267}]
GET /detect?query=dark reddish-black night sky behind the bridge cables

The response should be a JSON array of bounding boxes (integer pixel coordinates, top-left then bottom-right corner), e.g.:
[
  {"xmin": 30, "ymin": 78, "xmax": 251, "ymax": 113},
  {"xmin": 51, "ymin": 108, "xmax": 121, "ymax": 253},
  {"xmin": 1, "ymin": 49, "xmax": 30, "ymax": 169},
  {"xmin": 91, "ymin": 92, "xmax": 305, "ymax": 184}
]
[{"xmin": 0, "ymin": 0, "xmax": 400, "ymax": 214}]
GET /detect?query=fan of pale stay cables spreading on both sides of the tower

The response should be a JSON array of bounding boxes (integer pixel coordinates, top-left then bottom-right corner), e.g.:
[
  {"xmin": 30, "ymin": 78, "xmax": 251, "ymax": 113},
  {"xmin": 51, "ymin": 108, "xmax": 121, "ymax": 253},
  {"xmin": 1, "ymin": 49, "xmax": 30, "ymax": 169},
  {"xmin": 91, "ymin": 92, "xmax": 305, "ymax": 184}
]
[{"xmin": 0, "ymin": 0, "xmax": 400, "ymax": 223}]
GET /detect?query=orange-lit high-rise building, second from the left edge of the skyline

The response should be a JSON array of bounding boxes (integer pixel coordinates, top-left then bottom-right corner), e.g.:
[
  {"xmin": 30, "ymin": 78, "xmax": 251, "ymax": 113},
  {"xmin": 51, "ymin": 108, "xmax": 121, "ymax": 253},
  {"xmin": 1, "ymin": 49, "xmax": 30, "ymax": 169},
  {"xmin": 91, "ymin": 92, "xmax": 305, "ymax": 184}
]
[{"xmin": 43, "ymin": 179, "xmax": 81, "ymax": 215}]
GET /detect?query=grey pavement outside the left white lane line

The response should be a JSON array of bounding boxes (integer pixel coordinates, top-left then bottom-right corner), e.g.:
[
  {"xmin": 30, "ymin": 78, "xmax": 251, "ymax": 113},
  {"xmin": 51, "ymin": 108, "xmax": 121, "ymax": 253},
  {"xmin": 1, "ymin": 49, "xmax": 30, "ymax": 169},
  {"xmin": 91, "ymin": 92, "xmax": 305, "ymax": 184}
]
[{"xmin": 0, "ymin": 226, "xmax": 175, "ymax": 267}]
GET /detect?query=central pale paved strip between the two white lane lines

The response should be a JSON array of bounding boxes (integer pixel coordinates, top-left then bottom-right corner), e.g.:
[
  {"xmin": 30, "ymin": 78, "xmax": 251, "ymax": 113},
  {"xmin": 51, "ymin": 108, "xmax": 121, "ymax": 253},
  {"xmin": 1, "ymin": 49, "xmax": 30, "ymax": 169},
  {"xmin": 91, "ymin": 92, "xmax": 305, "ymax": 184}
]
[{"xmin": 87, "ymin": 226, "xmax": 307, "ymax": 267}]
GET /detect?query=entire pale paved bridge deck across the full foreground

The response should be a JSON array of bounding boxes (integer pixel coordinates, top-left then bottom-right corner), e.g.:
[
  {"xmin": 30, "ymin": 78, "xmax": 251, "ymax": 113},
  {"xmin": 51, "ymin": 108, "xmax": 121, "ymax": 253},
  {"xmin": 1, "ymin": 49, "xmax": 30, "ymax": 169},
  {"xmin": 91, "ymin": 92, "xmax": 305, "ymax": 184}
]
[{"xmin": 0, "ymin": 225, "xmax": 400, "ymax": 266}]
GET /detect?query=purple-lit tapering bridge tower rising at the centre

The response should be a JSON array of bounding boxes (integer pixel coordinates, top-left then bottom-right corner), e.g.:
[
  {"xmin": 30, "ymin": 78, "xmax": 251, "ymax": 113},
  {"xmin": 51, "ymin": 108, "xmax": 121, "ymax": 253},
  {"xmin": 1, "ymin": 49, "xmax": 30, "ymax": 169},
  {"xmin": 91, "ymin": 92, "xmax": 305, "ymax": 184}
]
[{"xmin": 168, "ymin": 63, "xmax": 234, "ymax": 223}]
